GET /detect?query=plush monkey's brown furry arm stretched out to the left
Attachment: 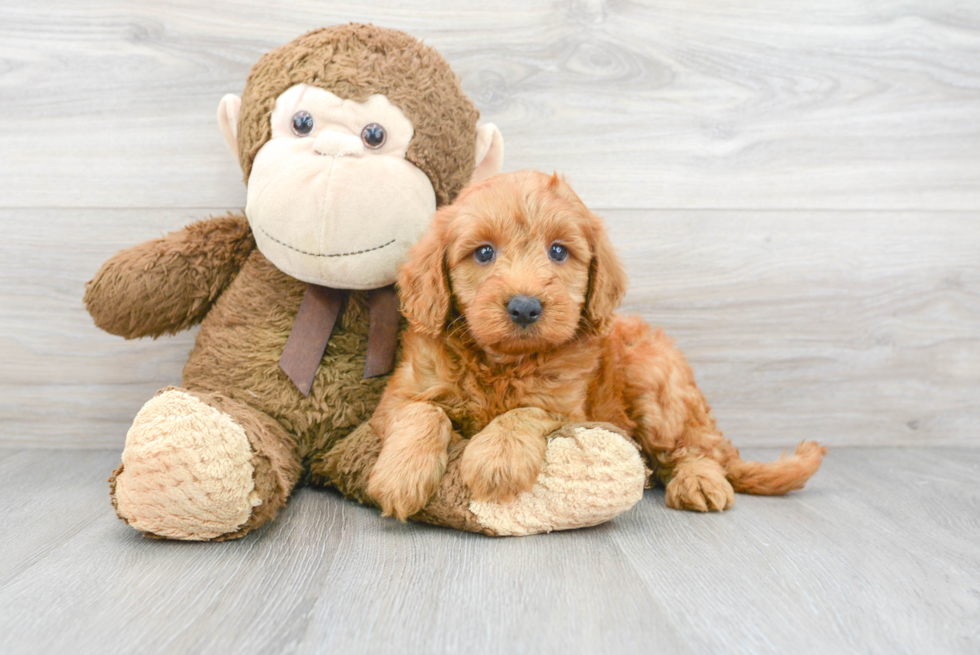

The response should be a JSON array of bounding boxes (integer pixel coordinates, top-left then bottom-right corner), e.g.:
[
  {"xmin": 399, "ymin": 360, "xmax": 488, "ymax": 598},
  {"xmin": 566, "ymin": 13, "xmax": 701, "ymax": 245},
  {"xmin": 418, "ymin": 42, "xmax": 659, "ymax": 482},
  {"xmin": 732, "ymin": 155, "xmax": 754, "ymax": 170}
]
[{"xmin": 85, "ymin": 214, "xmax": 255, "ymax": 339}]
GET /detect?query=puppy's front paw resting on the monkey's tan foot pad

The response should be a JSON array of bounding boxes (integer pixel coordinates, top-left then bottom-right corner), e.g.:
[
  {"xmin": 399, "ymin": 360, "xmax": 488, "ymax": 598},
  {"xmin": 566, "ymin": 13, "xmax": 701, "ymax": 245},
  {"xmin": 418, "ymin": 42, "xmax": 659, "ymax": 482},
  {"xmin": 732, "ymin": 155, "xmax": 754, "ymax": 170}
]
[{"xmin": 459, "ymin": 432, "xmax": 548, "ymax": 503}]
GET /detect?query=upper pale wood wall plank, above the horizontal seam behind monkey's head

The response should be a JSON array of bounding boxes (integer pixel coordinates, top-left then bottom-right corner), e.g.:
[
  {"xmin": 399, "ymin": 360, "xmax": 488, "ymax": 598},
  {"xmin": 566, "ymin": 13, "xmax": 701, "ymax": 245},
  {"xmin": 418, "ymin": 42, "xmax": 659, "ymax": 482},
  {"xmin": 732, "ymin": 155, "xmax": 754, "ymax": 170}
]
[{"xmin": 0, "ymin": 0, "xmax": 980, "ymax": 211}]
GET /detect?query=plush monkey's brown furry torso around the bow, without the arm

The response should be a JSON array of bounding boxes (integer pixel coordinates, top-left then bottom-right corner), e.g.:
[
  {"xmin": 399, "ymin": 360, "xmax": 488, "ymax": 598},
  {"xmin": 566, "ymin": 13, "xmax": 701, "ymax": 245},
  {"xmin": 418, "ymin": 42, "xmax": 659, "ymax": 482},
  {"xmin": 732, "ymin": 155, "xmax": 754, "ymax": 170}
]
[{"xmin": 184, "ymin": 243, "xmax": 387, "ymax": 460}]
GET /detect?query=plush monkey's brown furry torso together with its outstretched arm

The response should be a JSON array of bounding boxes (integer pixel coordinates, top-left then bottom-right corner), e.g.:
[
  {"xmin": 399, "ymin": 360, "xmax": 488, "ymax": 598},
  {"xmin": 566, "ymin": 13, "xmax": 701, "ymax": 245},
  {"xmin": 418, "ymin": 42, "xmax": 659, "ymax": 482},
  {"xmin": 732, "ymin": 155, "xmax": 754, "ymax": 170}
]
[{"xmin": 85, "ymin": 215, "xmax": 387, "ymax": 476}]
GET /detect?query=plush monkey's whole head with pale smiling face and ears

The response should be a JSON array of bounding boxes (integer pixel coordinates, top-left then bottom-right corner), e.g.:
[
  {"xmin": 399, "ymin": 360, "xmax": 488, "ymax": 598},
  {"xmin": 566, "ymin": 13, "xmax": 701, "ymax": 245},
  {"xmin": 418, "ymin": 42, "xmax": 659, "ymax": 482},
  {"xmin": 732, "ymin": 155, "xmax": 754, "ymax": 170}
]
[{"xmin": 218, "ymin": 24, "xmax": 503, "ymax": 289}]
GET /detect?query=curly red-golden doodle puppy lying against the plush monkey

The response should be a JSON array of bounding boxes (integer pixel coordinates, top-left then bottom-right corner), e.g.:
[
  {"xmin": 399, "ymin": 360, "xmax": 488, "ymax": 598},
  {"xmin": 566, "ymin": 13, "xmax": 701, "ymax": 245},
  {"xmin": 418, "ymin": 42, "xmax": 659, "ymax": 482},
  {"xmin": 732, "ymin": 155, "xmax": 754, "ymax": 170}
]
[{"xmin": 368, "ymin": 171, "xmax": 826, "ymax": 520}]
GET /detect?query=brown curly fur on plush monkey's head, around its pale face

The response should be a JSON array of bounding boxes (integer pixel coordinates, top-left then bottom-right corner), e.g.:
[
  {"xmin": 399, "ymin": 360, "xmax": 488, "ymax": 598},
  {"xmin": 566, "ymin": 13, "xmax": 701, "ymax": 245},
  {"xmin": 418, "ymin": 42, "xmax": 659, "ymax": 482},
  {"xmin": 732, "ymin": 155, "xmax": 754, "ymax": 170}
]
[{"xmin": 238, "ymin": 24, "xmax": 480, "ymax": 205}]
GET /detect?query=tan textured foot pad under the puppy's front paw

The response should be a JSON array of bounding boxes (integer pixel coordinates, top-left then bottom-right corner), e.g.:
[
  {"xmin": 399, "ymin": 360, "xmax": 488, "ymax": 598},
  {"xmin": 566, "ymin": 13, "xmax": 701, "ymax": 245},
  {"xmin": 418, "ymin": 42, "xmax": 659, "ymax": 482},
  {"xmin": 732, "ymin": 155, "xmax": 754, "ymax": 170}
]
[{"xmin": 470, "ymin": 427, "xmax": 646, "ymax": 536}]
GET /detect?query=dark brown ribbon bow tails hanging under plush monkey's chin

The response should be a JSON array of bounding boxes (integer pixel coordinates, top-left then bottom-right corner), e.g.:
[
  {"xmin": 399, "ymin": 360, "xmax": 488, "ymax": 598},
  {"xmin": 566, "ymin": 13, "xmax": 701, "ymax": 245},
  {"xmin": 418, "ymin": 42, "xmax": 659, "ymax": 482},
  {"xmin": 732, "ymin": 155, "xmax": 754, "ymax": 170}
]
[{"xmin": 279, "ymin": 284, "xmax": 398, "ymax": 396}]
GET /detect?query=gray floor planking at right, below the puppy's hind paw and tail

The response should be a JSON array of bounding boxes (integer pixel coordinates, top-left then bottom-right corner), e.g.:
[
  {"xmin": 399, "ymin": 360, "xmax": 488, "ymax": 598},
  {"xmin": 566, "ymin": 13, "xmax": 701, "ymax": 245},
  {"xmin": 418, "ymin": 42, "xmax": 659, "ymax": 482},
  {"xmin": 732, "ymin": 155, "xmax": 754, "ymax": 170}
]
[{"xmin": 612, "ymin": 449, "xmax": 980, "ymax": 655}]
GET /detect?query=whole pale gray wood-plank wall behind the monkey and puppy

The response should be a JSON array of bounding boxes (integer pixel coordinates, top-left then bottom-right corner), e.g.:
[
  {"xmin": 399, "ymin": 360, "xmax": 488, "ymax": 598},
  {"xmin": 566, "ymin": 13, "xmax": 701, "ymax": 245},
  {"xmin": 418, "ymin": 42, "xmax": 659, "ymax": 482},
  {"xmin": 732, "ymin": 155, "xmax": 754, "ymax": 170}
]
[{"xmin": 0, "ymin": 0, "xmax": 980, "ymax": 447}]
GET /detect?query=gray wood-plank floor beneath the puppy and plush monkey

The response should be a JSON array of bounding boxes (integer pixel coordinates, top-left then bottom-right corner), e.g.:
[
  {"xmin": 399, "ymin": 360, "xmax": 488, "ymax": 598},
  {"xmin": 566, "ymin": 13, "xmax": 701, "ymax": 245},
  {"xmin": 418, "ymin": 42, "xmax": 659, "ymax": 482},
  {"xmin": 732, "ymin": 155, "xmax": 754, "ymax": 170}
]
[{"xmin": 0, "ymin": 448, "xmax": 980, "ymax": 655}]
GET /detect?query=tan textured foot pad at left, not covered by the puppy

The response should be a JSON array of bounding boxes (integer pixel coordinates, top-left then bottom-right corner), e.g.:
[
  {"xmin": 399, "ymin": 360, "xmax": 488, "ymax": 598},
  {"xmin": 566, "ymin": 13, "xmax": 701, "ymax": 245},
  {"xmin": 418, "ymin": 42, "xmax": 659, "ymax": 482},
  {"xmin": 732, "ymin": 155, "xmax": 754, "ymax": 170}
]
[{"xmin": 115, "ymin": 389, "xmax": 261, "ymax": 541}]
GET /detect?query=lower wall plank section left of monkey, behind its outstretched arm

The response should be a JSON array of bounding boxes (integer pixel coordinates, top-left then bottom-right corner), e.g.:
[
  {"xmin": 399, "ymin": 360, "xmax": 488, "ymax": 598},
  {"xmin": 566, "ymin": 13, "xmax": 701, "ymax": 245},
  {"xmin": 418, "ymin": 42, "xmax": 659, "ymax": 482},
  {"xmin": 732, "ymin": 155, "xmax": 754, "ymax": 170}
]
[{"xmin": 0, "ymin": 210, "xmax": 209, "ymax": 448}]
